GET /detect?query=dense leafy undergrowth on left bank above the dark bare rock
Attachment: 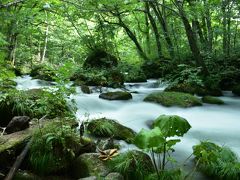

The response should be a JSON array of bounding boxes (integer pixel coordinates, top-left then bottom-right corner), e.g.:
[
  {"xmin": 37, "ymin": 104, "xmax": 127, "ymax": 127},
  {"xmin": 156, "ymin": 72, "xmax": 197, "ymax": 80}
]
[{"xmin": 0, "ymin": 89, "xmax": 75, "ymax": 118}]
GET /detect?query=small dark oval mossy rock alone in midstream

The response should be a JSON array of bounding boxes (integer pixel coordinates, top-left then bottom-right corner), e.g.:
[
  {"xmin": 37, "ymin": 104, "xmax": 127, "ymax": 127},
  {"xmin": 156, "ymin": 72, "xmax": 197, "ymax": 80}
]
[{"xmin": 99, "ymin": 91, "xmax": 132, "ymax": 100}]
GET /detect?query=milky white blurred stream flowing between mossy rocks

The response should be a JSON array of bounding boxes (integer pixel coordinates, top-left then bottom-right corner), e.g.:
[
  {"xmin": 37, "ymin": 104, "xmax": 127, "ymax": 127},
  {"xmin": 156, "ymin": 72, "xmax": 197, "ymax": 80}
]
[{"xmin": 16, "ymin": 76, "xmax": 240, "ymax": 179}]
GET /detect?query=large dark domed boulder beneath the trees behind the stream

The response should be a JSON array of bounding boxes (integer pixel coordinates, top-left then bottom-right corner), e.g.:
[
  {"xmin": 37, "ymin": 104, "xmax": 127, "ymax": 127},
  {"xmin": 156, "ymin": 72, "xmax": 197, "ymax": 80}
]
[{"xmin": 83, "ymin": 49, "xmax": 118, "ymax": 68}]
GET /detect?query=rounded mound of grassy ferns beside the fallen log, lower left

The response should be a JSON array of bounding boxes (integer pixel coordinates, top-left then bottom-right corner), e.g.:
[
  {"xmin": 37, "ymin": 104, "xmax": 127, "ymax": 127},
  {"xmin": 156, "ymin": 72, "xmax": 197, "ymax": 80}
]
[{"xmin": 29, "ymin": 122, "xmax": 80, "ymax": 175}]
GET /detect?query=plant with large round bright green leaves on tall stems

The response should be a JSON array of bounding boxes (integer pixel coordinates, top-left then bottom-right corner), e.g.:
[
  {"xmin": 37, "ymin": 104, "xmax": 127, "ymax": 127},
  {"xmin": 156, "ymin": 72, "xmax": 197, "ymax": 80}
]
[{"xmin": 134, "ymin": 115, "xmax": 191, "ymax": 179}]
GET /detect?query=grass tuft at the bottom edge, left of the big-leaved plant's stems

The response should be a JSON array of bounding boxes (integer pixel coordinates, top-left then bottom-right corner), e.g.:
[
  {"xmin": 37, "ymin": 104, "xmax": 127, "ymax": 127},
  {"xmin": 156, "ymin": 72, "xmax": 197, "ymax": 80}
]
[{"xmin": 109, "ymin": 151, "xmax": 153, "ymax": 180}]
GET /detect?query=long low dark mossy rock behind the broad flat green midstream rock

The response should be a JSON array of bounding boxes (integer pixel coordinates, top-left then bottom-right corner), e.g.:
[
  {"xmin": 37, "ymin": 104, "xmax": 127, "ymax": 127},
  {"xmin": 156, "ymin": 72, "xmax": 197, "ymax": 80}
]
[{"xmin": 165, "ymin": 83, "xmax": 222, "ymax": 96}]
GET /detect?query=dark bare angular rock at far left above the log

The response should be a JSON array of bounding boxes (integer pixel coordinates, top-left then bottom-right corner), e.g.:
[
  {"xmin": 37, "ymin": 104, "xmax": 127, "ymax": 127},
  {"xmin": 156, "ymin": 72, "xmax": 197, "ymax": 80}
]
[{"xmin": 5, "ymin": 116, "xmax": 30, "ymax": 134}]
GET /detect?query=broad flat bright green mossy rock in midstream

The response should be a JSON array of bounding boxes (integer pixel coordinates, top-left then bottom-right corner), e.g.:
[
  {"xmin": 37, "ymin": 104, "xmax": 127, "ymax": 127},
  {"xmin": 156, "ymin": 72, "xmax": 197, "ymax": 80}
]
[{"xmin": 144, "ymin": 92, "xmax": 202, "ymax": 107}]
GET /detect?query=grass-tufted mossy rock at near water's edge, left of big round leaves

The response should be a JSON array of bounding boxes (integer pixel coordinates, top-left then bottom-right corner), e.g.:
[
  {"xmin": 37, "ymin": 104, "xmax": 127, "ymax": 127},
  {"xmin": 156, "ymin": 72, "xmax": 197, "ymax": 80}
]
[{"xmin": 87, "ymin": 118, "xmax": 136, "ymax": 142}]
